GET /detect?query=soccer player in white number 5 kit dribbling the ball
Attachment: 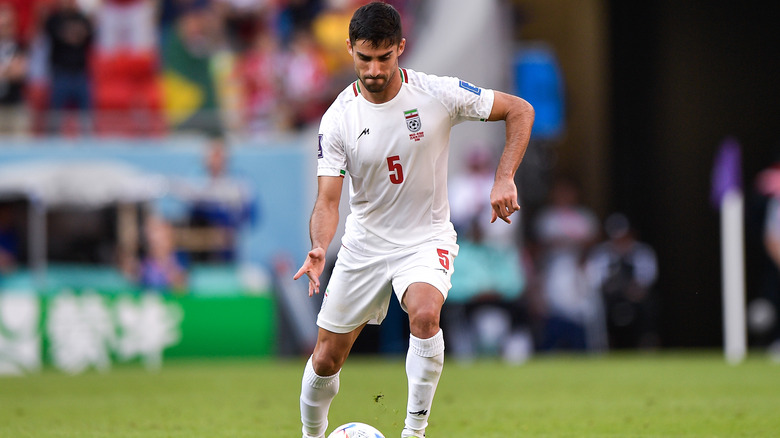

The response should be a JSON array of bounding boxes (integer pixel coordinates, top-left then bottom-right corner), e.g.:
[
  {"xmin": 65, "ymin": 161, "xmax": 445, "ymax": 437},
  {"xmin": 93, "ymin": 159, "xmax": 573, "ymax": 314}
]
[{"xmin": 294, "ymin": 2, "xmax": 534, "ymax": 438}]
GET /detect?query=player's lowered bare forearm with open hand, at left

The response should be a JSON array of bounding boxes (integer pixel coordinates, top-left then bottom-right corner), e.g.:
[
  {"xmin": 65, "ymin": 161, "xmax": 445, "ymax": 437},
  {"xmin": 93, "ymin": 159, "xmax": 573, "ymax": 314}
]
[{"xmin": 293, "ymin": 176, "xmax": 344, "ymax": 296}]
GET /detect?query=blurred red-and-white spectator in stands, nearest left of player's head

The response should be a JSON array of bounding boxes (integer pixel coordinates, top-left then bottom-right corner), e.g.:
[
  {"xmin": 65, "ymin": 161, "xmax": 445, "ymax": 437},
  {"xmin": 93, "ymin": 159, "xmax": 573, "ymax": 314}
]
[{"xmin": 282, "ymin": 29, "xmax": 332, "ymax": 129}]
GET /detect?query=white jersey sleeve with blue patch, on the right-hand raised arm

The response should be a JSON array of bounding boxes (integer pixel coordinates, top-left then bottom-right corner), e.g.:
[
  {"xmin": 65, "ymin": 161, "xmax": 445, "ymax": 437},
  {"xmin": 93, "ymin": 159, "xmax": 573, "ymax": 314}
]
[{"xmin": 408, "ymin": 73, "xmax": 495, "ymax": 125}]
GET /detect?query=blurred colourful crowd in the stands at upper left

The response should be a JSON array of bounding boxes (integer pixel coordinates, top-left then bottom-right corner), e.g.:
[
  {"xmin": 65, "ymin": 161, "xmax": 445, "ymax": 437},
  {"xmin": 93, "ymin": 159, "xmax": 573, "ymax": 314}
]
[{"xmin": 0, "ymin": 0, "xmax": 414, "ymax": 138}]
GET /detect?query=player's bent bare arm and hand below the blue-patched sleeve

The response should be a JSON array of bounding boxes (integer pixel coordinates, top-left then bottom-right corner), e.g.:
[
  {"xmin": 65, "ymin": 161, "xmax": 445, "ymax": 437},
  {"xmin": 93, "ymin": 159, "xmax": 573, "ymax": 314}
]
[{"xmin": 488, "ymin": 91, "xmax": 534, "ymax": 223}]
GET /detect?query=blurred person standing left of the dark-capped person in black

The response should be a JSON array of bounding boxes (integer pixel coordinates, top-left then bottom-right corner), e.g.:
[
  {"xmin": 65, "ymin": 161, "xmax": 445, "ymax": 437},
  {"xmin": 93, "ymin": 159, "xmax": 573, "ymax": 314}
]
[{"xmin": 534, "ymin": 177, "xmax": 605, "ymax": 351}]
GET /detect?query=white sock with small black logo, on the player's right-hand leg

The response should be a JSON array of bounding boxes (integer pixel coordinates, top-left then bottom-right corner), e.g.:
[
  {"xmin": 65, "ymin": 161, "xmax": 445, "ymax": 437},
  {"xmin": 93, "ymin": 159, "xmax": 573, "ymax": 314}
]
[{"xmin": 405, "ymin": 330, "xmax": 444, "ymax": 430}]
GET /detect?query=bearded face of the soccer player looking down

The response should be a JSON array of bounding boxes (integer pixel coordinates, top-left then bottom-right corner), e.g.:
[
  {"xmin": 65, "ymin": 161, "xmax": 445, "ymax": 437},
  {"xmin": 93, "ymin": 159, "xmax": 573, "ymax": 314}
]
[{"xmin": 347, "ymin": 40, "xmax": 406, "ymax": 94}]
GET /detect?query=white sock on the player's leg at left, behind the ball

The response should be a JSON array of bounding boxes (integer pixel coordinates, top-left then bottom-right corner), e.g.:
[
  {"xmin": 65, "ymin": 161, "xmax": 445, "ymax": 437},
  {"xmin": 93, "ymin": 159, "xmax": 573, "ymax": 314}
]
[{"xmin": 301, "ymin": 357, "xmax": 339, "ymax": 438}]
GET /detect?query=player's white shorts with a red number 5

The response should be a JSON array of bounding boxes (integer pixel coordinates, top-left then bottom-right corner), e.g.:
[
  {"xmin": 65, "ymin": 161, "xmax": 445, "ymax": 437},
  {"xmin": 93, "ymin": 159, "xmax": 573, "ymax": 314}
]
[{"xmin": 317, "ymin": 241, "xmax": 458, "ymax": 333}]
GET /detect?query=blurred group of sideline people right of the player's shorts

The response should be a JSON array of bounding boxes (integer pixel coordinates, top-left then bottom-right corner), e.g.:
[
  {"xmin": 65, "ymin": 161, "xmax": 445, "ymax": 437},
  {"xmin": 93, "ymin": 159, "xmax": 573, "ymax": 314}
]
[{"xmin": 443, "ymin": 145, "xmax": 660, "ymax": 363}]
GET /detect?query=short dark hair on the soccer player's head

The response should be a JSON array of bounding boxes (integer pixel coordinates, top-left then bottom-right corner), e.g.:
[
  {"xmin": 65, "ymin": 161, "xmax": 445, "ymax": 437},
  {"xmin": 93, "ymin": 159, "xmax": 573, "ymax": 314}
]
[{"xmin": 349, "ymin": 2, "xmax": 403, "ymax": 47}]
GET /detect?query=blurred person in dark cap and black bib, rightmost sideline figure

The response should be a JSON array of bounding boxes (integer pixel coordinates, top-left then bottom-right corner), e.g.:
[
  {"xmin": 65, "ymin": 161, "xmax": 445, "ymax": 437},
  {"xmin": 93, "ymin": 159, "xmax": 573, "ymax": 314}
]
[{"xmin": 587, "ymin": 213, "xmax": 659, "ymax": 349}]
